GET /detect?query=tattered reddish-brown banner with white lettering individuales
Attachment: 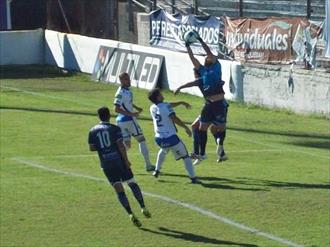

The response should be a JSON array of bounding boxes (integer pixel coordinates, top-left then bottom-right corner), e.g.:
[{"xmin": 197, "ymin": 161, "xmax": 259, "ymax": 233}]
[{"xmin": 225, "ymin": 17, "xmax": 307, "ymax": 63}]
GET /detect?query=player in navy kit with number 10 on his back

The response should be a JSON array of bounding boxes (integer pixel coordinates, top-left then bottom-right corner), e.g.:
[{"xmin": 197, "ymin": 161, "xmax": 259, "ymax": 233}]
[{"xmin": 88, "ymin": 107, "xmax": 151, "ymax": 227}]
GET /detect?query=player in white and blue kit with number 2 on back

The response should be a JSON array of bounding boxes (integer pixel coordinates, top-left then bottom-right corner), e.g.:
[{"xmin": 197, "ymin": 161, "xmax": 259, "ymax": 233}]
[{"xmin": 148, "ymin": 88, "xmax": 199, "ymax": 183}]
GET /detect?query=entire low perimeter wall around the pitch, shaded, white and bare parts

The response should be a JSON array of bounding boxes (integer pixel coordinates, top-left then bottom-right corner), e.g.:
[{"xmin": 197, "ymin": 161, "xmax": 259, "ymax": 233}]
[{"xmin": 0, "ymin": 30, "xmax": 330, "ymax": 117}]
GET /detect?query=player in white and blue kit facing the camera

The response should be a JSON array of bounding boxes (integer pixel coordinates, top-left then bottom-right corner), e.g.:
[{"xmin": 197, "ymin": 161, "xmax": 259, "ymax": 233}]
[{"xmin": 114, "ymin": 73, "xmax": 155, "ymax": 171}]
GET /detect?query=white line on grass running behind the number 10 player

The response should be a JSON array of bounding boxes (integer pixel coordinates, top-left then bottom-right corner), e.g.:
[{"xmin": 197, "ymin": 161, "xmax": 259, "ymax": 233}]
[{"xmin": 12, "ymin": 158, "xmax": 304, "ymax": 247}]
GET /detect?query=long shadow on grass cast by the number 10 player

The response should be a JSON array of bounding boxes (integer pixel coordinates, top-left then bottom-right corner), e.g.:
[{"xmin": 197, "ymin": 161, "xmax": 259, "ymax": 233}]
[{"xmin": 140, "ymin": 227, "xmax": 258, "ymax": 247}]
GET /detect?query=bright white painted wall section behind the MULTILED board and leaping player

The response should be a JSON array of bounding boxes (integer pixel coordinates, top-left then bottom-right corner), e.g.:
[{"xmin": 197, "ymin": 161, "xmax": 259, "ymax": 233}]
[{"xmin": 45, "ymin": 30, "xmax": 240, "ymax": 99}]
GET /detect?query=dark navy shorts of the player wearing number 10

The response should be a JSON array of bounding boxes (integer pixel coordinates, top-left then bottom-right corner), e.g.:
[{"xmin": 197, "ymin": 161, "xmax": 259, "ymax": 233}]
[{"xmin": 102, "ymin": 159, "xmax": 134, "ymax": 185}]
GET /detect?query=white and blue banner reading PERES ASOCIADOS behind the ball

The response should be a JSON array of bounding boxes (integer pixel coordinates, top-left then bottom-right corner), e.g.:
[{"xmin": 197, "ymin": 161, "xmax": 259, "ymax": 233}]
[{"xmin": 150, "ymin": 9, "xmax": 223, "ymax": 55}]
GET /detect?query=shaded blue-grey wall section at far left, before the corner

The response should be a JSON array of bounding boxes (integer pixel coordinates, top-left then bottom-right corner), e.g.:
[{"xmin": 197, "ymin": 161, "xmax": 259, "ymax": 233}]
[{"xmin": 0, "ymin": 29, "xmax": 44, "ymax": 65}]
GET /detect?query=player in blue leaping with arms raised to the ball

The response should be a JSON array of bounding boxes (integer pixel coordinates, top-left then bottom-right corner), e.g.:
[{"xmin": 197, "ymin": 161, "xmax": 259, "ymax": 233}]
[{"xmin": 175, "ymin": 34, "xmax": 228, "ymax": 164}]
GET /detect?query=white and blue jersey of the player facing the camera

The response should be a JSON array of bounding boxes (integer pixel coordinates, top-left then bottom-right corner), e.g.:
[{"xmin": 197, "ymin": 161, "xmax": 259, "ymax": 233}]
[{"xmin": 113, "ymin": 87, "xmax": 133, "ymax": 122}]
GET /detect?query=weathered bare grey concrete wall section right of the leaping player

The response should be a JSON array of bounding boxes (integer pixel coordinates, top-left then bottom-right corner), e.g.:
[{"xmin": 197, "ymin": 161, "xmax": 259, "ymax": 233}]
[{"xmin": 243, "ymin": 65, "xmax": 330, "ymax": 117}]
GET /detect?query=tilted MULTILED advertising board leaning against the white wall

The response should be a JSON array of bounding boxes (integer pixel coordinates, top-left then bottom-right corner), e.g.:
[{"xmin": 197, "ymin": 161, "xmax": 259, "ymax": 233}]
[{"xmin": 92, "ymin": 46, "xmax": 164, "ymax": 89}]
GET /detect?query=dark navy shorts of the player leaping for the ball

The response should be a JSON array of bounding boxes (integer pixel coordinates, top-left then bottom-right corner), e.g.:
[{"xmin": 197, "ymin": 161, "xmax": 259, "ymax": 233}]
[{"xmin": 200, "ymin": 100, "xmax": 228, "ymax": 125}]
